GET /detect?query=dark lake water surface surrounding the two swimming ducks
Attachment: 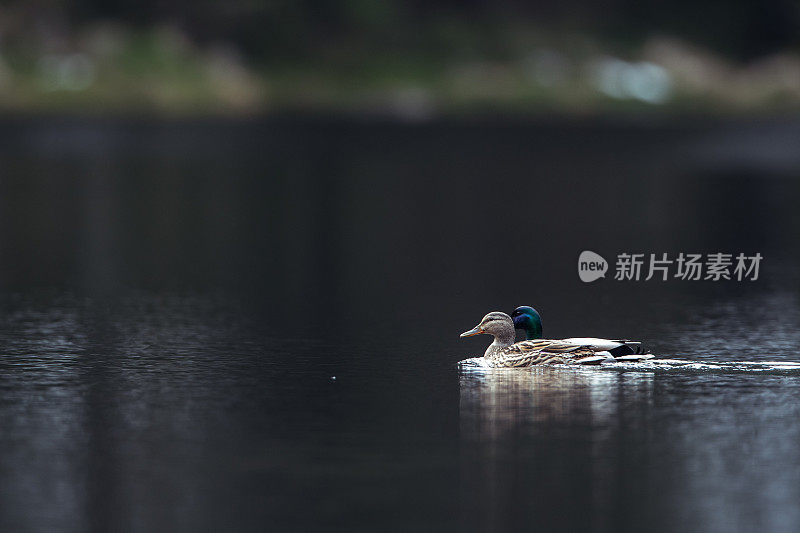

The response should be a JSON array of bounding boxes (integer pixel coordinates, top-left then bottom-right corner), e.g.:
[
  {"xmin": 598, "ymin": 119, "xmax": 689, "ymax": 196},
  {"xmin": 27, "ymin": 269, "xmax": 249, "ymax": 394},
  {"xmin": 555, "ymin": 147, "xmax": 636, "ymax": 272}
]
[{"xmin": 0, "ymin": 119, "xmax": 800, "ymax": 532}]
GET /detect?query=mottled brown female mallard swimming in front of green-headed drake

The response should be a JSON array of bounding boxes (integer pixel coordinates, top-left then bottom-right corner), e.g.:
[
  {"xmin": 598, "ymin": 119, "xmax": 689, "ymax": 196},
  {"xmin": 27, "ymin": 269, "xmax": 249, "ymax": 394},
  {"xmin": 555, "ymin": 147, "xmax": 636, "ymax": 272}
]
[{"xmin": 461, "ymin": 311, "xmax": 610, "ymax": 367}]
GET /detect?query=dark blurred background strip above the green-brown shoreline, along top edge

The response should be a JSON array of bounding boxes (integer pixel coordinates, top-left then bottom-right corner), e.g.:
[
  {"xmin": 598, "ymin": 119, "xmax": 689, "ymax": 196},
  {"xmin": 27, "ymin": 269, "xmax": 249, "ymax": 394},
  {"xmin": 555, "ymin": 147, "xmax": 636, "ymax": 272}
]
[{"xmin": 4, "ymin": 0, "xmax": 800, "ymax": 61}]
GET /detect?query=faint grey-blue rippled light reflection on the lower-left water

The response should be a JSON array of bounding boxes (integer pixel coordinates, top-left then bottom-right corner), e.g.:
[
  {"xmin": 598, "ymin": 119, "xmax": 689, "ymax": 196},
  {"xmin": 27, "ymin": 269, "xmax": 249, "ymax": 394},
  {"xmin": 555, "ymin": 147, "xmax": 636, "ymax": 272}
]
[{"xmin": 0, "ymin": 294, "xmax": 258, "ymax": 531}]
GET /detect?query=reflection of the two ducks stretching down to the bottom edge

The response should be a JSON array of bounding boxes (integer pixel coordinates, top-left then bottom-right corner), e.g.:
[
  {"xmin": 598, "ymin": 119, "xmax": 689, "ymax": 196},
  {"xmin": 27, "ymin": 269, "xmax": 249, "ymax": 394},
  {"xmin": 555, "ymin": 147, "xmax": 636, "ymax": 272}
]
[{"xmin": 459, "ymin": 367, "xmax": 654, "ymax": 530}]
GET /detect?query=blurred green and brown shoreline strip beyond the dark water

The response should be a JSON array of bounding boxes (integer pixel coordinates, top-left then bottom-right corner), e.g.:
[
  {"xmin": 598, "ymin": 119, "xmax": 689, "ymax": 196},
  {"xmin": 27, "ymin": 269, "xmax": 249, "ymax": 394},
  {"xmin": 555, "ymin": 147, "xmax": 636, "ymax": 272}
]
[{"xmin": 0, "ymin": 25, "xmax": 800, "ymax": 116}]
